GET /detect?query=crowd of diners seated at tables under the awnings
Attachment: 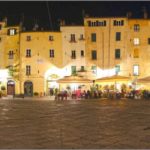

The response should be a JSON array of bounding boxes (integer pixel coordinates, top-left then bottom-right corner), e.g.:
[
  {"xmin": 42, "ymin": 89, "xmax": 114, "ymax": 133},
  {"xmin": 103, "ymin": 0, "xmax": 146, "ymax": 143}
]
[{"xmin": 50, "ymin": 89, "xmax": 150, "ymax": 100}]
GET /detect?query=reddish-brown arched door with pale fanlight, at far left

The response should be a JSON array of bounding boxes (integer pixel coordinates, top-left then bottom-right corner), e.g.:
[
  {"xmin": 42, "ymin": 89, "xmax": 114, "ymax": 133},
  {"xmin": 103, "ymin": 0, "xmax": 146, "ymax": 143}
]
[{"xmin": 7, "ymin": 80, "xmax": 15, "ymax": 95}]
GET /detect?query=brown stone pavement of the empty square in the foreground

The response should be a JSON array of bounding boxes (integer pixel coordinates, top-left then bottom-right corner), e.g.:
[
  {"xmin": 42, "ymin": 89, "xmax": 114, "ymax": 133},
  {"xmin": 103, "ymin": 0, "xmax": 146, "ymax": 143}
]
[{"xmin": 0, "ymin": 100, "xmax": 150, "ymax": 149}]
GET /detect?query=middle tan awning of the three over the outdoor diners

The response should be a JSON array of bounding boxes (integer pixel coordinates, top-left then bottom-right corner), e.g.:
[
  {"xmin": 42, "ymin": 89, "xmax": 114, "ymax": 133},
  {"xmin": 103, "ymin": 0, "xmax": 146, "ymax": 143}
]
[{"xmin": 96, "ymin": 75, "xmax": 130, "ymax": 82}]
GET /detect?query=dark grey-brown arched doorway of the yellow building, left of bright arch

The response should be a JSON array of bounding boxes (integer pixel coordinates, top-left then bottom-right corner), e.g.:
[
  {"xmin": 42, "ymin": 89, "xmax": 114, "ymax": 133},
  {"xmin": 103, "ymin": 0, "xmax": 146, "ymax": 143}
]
[{"xmin": 24, "ymin": 81, "xmax": 33, "ymax": 96}]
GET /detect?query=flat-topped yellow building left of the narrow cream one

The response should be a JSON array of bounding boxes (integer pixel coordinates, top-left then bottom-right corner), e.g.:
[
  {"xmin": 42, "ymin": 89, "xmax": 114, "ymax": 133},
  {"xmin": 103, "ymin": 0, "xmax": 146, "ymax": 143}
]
[{"xmin": 20, "ymin": 31, "xmax": 63, "ymax": 96}]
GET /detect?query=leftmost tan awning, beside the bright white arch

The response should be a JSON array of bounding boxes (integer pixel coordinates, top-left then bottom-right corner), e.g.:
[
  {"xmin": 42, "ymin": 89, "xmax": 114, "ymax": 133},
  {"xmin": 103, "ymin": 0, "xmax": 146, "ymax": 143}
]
[{"xmin": 57, "ymin": 76, "xmax": 92, "ymax": 83}]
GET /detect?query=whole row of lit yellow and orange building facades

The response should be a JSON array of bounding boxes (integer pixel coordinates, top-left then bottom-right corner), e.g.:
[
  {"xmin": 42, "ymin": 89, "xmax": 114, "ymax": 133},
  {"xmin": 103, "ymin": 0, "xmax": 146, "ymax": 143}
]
[{"xmin": 0, "ymin": 13, "xmax": 150, "ymax": 96}]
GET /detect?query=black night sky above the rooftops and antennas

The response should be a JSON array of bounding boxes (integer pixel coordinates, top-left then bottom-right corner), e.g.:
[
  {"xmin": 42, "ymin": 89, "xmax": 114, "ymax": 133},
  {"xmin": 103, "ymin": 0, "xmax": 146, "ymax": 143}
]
[{"xmin": 0, "ymin": 1, "xmax": 150, "ymax": 29}]
